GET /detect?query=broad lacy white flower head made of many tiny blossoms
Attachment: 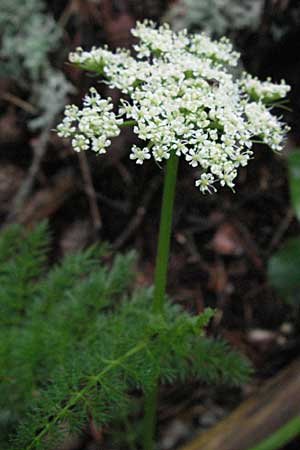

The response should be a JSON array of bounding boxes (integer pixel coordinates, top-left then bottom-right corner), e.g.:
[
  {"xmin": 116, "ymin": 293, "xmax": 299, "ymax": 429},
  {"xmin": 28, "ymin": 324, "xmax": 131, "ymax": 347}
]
[{"xmin": 57, "ymin": 21, "xmax": 290, "ymax": 193}]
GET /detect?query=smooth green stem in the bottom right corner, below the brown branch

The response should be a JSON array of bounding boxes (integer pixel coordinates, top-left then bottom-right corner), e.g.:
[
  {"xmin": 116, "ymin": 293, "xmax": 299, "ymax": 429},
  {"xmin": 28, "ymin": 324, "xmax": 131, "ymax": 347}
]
[{"xmin": 249, "ymin": 416, "xmax": 300, "ymax": 450}]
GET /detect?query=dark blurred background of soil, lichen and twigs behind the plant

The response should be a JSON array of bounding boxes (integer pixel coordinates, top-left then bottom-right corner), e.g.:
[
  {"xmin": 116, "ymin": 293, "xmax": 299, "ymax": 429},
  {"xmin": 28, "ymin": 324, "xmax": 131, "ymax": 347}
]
[{"xmin": 0, "ymin": 0, "xmax": 300, "ymax": 450}]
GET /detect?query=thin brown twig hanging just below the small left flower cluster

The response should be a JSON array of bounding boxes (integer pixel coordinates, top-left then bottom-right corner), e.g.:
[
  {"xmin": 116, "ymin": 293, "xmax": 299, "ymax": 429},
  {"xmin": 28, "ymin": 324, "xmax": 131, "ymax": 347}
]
[{"xmin": 78, "ymin": 152, "xmax": 102, "ymax": 234}]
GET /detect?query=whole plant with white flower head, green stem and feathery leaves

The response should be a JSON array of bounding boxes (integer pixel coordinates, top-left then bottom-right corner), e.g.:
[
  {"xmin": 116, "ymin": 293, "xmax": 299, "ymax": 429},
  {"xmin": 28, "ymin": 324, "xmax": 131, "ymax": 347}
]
[{"xmin": 0, "ymin": 21, "xmax": 289, "ymax": 450}]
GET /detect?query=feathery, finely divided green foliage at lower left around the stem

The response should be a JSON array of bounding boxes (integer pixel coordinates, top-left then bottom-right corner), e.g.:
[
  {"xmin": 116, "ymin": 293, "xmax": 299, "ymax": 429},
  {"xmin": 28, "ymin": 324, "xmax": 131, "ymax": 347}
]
[{"xmin": 0, "ymin": 223, "xmax": 249, "ymax": 450}]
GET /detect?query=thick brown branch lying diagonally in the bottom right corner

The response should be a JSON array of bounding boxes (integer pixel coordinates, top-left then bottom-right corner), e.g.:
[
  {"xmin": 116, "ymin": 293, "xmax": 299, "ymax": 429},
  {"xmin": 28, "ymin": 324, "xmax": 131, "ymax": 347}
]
[{"xmin": 180, "ymin": 359, "xmax": 300, "ymax": 450}]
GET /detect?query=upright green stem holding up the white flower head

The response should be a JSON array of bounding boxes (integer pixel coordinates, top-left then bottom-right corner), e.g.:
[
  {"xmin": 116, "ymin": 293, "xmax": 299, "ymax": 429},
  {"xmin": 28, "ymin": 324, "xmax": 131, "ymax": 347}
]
[{"xmin": 143, "ymin": 152, "xmax": 178, "ymax": 450}]
